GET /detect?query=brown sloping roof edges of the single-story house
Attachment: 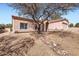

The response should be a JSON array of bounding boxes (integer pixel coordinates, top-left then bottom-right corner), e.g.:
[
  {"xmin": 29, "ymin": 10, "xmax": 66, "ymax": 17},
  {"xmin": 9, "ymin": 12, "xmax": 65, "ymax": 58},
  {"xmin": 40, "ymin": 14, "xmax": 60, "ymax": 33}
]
[{"xmin": 12, "ymin": 16, "xmax": 69, "ymax": 23}]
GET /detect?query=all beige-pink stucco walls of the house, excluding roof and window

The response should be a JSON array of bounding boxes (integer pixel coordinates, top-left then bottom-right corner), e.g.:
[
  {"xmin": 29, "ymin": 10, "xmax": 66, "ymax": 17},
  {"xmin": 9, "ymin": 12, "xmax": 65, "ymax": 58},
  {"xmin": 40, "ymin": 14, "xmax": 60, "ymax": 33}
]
[{"xmin": 12, "ymin": 19, "xmax": 68, "ymax": 32}]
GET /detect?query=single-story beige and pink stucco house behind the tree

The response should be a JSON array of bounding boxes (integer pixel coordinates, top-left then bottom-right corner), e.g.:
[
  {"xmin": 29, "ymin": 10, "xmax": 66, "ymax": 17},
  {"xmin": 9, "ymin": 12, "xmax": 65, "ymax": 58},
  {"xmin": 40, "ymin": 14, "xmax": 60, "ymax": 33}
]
[{"xmin": 12, "ymin": 16, "xmax": 69, "ymax": 32}]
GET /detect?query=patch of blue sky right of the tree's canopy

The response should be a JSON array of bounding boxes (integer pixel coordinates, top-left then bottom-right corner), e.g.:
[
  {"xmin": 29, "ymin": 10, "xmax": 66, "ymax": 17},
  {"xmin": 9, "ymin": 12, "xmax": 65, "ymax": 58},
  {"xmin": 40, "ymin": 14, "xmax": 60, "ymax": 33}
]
[{"xmin": 63, "ymin": 9, "xmax": 79, "ymax": 24}]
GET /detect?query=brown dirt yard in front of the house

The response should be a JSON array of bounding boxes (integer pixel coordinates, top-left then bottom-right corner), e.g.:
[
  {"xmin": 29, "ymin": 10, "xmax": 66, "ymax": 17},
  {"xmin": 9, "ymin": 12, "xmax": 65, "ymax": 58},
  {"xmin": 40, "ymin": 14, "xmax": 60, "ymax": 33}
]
[{"xmin": 0, "ymin": 28, "xmax": 79, "ymax": 56}]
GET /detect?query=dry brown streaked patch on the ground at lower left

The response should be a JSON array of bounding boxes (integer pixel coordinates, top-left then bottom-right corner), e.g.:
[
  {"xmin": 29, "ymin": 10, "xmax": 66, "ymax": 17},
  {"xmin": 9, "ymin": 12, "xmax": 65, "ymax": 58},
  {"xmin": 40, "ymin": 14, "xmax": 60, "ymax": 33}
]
[{"xmin": 0, "ymin": 35, "xmax": 34, "ymax": 56}]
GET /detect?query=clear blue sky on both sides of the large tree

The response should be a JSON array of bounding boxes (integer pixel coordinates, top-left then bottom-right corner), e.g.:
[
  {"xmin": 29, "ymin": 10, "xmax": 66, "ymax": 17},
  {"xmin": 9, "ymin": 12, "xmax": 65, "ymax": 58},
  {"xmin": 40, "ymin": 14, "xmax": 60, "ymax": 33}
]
[{"xmin": 0, "ymin": 3, "xmax": 79, "ymax": 24}]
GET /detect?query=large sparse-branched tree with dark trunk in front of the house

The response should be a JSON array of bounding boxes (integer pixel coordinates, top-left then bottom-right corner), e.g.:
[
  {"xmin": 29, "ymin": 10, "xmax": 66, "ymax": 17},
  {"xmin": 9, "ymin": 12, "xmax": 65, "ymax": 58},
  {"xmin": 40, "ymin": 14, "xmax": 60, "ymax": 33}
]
[{"xmin": 8, "ymin": 3, "xmax": 79, "ymax": 32}]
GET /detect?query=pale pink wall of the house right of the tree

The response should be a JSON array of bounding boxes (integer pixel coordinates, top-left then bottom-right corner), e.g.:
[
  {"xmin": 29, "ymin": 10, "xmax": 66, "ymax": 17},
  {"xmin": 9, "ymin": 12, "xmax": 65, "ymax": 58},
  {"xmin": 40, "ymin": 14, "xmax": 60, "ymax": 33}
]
[{"xmin": 48, "ymin": 21, "xmax": 68, "ymax": 31}]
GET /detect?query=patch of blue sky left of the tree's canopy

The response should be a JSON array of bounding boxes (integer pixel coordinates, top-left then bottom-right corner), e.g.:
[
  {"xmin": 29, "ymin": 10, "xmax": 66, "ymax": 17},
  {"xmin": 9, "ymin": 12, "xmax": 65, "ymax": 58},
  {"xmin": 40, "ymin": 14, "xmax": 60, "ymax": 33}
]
[{"xmin": 0, "ymin": 4, "xmax": 17, "ymax": 24}]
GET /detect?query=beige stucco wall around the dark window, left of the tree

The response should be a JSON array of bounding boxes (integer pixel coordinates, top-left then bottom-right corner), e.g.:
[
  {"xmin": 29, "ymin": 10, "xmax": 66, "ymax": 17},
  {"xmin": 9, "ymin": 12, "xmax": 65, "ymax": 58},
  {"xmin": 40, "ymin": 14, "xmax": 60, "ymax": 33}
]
[{"xmin": 12, "ymin": 19, "xmax": 35, "ymax": 32}]
